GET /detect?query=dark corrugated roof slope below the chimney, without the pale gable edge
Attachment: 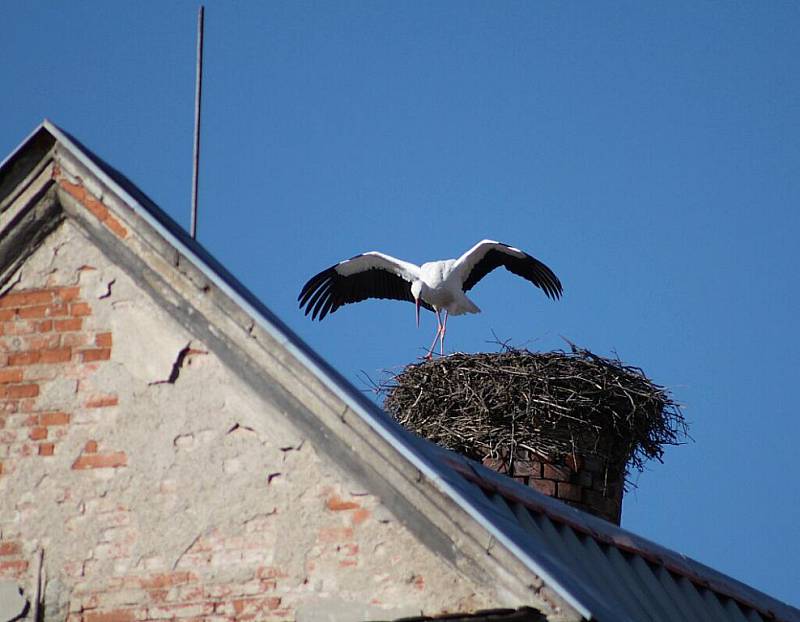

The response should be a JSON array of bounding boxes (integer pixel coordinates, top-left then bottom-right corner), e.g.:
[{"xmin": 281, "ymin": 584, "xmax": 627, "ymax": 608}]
[{"xmin": 441, "ymin": 452, "xmax": 800, "ymax": 622}]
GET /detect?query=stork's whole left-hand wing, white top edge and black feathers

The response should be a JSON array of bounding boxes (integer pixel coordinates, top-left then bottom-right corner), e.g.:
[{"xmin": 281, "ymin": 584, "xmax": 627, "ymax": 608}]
[{"xmin": 297, "ymin": 251, "xmax": 431, "ymax": 320}]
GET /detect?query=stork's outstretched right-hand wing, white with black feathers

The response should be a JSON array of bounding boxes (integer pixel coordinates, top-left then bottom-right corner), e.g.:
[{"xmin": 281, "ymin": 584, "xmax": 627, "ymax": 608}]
[{"xmin": 456, "ymin": 240, "xmax": 562, "ymax": 299}]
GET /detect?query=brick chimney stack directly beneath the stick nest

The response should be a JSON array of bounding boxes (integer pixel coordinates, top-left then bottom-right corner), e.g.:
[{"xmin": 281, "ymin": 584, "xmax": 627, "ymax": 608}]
[{"xmin": 484, "ymin": 449, "xmax": 624, "ymax": 525}]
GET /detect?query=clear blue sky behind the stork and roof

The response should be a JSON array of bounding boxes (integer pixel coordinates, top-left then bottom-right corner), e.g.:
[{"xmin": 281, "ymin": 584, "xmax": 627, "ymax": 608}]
[{"xmin": 0, "ymin": 1, "xmax": 800, "ymax": 606}]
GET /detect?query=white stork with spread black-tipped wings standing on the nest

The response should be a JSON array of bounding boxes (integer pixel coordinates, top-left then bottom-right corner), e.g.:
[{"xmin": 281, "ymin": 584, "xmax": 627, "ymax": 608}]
[{"xmin": 297, "ymin": 240, "xmax": 562, "ymax": 358}]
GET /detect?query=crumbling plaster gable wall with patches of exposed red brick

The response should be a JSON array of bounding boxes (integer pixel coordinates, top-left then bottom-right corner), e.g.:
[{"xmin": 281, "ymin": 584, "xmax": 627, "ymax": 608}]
[{"xmin": 0, "ymin": 220, "xmax": 497, "ymax": 622}]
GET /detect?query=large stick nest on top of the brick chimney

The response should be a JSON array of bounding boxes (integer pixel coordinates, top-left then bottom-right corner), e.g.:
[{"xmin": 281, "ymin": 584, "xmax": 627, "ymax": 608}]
[{"xmin": 382, "ymin": 345, "xmax": 687, "ymax": 474}]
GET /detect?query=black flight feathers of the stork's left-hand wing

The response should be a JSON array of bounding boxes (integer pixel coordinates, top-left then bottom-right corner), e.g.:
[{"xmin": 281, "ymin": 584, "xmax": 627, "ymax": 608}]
[{"xmin": 297, "ymin": 264, "xmax": 433, "ymax": 320}]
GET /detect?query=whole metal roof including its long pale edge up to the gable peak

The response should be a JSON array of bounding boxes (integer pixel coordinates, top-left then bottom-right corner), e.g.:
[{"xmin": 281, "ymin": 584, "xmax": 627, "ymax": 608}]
[{"xmin": 0, "ymin": 121, "xmax": 800, "ymax": 622}]
